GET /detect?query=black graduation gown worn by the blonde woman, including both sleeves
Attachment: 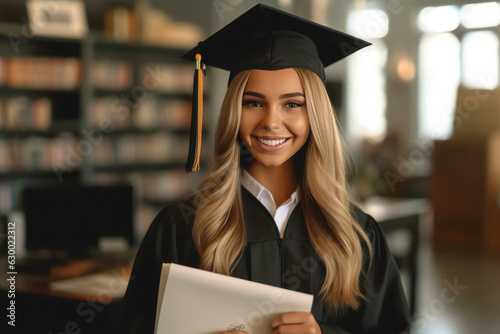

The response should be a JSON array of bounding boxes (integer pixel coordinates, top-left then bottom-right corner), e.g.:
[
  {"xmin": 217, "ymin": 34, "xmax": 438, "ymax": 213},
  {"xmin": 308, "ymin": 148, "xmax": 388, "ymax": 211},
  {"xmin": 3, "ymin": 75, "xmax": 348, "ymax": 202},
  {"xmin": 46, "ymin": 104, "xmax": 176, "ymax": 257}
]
[{"xmin": 117, "ymin": 187, "xmax": 409, "ymax": 334}]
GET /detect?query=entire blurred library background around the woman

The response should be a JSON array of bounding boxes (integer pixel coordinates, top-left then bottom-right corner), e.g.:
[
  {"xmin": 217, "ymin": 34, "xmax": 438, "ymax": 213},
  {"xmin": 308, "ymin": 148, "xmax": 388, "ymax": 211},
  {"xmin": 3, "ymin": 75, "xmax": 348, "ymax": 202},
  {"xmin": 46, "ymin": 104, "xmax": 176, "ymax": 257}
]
[{"xmin": 0, "ymin": 0, "xmax": 500, "ymax": 334}]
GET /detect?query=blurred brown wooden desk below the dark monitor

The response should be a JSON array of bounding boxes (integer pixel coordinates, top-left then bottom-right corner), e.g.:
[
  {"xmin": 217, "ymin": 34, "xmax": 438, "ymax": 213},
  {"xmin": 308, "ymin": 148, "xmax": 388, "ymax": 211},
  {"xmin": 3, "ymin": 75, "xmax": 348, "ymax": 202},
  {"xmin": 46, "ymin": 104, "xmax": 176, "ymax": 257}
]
[{"xmin": 0, "ymin": 254, "xmax": 133, "ymax": 334}]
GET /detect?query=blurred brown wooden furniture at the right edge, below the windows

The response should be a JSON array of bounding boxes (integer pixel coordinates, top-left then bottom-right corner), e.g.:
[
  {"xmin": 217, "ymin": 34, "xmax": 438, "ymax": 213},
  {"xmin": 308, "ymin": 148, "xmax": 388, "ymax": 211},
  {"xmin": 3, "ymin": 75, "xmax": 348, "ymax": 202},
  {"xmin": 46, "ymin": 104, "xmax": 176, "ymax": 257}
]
[{"xmin": 431, "ymin": 136, "xmax": 500, "ymax": 255}]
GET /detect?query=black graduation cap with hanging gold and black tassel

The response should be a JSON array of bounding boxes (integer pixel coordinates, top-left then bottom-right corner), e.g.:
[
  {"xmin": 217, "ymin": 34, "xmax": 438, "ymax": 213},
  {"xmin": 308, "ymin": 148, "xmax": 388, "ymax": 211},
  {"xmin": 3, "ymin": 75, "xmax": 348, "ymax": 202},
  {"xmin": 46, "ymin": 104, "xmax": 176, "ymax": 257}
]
[{"xmin": 183, "ymin": 4, "xmax": 370, "ymax": 172}]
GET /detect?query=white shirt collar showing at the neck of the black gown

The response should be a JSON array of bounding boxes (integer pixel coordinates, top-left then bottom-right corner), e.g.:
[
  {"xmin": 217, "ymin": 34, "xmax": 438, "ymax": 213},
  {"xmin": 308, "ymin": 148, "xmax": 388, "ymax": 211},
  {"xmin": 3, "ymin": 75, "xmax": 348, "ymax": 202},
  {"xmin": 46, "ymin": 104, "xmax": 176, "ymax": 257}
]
[{"xmin": 240, "ymin": 169, "xmax": 299, "ymax": 238}]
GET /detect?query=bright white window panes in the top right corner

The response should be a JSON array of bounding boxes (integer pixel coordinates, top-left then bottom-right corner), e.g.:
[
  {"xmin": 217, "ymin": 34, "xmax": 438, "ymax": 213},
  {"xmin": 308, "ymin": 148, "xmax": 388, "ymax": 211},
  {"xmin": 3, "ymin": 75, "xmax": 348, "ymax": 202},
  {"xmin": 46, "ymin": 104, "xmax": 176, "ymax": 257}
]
[{"xmin": 417, "ymin": 2, "xmax": 500, "ymax": 139}]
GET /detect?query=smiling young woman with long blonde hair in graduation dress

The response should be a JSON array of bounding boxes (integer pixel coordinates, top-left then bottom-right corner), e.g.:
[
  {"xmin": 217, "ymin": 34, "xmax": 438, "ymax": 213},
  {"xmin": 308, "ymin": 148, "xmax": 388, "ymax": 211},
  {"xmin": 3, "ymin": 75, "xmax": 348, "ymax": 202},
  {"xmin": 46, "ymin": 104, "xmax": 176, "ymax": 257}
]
[{"xmin": 116, "ymin": 6, "xmax": 409, "ymax": 333}]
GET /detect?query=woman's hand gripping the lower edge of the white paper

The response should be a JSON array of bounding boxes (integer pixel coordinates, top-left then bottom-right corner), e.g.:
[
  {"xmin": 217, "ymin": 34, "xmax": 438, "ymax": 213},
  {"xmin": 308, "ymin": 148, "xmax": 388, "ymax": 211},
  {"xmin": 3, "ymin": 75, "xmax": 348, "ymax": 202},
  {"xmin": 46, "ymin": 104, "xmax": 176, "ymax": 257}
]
[{"xmin": 271, "ymin": 312, "xmax": 321, "ymax": 334}]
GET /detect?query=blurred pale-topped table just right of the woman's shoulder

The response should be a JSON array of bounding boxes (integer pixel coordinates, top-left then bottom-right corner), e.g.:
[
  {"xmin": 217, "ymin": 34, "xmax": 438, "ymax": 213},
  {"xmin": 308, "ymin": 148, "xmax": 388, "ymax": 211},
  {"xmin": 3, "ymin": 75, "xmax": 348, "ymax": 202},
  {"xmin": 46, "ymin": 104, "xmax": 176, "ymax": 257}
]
[{"xmin": 362, "ymin": 197, "xmax": 429, "ymax": 313}]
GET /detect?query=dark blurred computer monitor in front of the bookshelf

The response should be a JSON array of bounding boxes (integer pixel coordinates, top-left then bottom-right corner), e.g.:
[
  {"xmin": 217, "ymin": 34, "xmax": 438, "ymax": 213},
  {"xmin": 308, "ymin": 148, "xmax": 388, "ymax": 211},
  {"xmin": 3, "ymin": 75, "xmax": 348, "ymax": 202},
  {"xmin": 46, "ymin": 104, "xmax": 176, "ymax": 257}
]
[{"xmin": 22, "ymin": 184, "xmax": 134, "ymax": 257}]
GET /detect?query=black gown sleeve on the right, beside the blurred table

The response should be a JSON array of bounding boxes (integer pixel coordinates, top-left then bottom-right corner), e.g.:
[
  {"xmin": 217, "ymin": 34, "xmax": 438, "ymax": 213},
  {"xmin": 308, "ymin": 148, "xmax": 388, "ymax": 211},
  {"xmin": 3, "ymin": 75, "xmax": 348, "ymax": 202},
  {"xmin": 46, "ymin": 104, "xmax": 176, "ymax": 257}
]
[{"xmin": 318, "ymin": 214, "xmax": 410, "ymax": 334}]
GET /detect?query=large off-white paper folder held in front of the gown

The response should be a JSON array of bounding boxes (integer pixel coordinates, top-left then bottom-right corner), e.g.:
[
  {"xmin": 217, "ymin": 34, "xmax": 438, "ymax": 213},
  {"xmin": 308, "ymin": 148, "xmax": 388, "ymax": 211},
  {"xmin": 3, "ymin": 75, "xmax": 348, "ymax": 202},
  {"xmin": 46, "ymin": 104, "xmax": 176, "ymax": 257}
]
[{"xmin": 155, "ymin": 264, "xmax": 313, "ymax": 334}]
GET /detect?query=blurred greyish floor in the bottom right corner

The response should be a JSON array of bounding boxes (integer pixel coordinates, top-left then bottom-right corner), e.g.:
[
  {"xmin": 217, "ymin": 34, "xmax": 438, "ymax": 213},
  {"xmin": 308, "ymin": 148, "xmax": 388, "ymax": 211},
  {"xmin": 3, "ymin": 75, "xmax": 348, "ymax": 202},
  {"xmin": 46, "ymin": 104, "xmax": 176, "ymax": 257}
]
[{"xmin": 411, "ymin": 240, "xmax": 500, "ymax": 334}]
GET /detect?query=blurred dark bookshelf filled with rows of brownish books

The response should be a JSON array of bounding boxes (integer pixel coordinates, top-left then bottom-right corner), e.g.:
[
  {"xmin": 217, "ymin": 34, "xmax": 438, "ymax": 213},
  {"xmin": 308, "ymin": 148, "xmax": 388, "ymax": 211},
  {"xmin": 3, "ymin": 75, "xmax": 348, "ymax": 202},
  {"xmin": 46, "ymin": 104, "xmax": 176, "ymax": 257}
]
[{"xmin": 0, "ymin": 25, "xmax": 207, "ymax": 238}]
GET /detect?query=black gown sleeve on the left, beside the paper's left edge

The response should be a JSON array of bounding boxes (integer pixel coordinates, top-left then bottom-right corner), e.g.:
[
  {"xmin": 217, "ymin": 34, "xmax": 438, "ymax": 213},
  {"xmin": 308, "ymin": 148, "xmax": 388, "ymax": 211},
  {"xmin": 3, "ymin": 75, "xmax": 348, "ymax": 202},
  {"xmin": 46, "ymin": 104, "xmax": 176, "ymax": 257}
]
[{"xmin": 115, "ymin": 201, "xmax": 196, "ymax": 334}]
